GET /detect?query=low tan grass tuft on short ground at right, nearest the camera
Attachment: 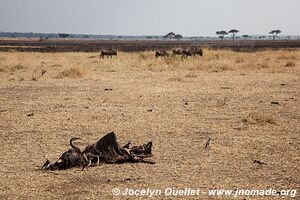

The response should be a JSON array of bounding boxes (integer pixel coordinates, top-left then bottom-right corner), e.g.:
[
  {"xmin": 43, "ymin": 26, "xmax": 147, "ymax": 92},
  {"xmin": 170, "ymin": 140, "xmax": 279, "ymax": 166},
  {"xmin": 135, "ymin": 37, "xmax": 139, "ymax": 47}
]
[{"xmin": 242, "ymin": 113, "xmax": 277, "ymax": 125}]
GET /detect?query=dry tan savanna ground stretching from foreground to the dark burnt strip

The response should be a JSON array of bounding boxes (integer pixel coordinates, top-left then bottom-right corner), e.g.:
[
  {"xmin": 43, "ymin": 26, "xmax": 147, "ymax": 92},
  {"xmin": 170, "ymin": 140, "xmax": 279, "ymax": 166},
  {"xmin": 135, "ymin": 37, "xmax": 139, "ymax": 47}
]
[{"xmin": 0, "ymin": 49, "xmax": 300, "ymax": 199}]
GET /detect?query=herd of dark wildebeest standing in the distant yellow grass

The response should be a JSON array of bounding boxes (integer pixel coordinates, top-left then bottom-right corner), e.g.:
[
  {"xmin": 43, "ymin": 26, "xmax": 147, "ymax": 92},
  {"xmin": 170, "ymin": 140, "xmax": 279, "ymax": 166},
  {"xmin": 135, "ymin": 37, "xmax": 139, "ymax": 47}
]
[{"xmin": 100, "ymin": 47, "xmax": 203, "ymax": 59}]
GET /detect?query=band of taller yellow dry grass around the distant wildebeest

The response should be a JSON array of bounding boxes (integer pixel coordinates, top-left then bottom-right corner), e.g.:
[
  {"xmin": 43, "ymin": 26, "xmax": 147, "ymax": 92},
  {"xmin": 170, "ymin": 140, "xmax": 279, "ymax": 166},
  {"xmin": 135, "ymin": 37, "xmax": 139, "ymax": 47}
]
[{"xmin": 0, "ymin": 49, "xmax": 300, "ymax": 78}]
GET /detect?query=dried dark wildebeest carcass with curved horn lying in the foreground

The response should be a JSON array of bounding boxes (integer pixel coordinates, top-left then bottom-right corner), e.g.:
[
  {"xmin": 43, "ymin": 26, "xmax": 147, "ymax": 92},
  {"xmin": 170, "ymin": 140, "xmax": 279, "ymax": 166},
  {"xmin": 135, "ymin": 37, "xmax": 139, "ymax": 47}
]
[{"xmin": 42, "ymin": 132, "xmax": 154, "ymax": 170}]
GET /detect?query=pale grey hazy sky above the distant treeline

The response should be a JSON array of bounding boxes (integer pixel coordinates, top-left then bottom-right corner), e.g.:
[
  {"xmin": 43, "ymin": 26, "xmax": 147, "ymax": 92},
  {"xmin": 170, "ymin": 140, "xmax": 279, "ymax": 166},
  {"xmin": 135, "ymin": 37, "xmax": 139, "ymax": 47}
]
[{"xmin": 0, "ymin": 0, "xmax": 300, "ymax": 36}]
